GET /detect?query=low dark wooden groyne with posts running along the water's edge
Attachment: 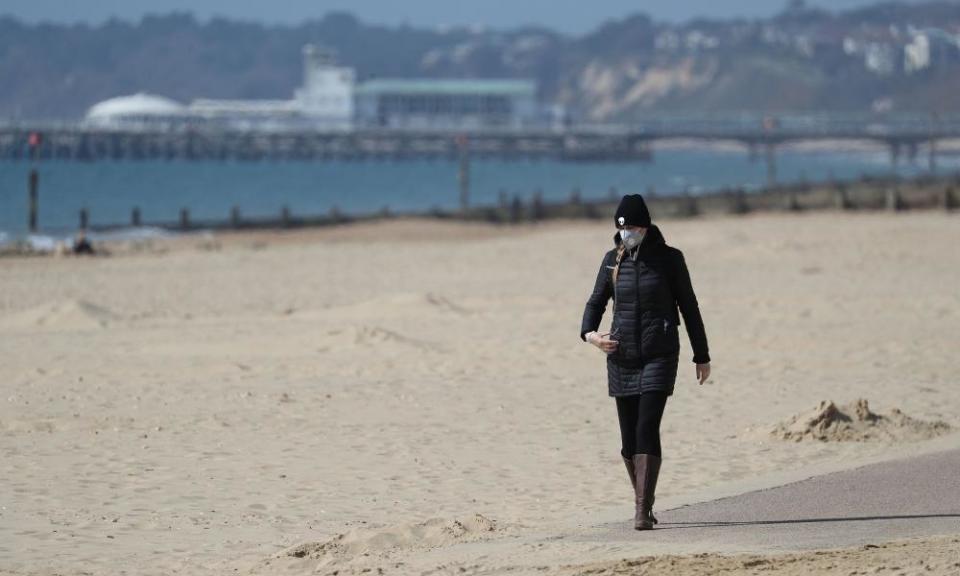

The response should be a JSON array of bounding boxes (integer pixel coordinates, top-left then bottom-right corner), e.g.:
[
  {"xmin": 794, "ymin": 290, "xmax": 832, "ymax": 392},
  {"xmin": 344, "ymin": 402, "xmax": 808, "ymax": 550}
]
[{"xmin": 78, "ymin": 173, "xmax": 960, "ymax": 232}]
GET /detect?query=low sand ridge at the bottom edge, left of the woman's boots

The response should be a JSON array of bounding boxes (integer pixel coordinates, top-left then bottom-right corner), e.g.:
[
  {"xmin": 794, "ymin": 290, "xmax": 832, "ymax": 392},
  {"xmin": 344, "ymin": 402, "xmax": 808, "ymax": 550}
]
[{"xmin": 254, "ymin": 514, "xmax": 498, "ymax": 574}]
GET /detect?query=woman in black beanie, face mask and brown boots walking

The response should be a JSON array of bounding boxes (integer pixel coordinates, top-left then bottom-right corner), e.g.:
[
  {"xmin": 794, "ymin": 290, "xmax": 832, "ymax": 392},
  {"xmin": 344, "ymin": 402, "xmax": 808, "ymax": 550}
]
[{"xmin": 580, "ymin": 194, "xmax": 710, "ymax": 530}]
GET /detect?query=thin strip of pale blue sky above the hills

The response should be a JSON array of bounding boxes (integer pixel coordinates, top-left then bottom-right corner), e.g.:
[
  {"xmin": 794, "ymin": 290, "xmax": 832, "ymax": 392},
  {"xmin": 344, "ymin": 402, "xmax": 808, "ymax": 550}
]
[{"xmin": 0, "ymin": 0, "xmax": 936, "ymax": 34}]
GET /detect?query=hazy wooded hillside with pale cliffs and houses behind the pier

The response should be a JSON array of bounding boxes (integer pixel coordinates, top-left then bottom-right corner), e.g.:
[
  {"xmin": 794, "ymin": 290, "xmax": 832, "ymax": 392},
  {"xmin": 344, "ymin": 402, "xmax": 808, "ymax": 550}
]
[{"xmin": 0, "ymin": 1, "xmax": 960, "ymax": 120}]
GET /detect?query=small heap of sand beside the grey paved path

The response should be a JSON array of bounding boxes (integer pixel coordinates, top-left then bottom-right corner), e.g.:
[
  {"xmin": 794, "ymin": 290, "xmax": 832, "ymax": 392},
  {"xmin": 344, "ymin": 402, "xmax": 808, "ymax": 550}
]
[{"xmin": 771, "ymin": 398, "xmax": 950, "ymax": 442}]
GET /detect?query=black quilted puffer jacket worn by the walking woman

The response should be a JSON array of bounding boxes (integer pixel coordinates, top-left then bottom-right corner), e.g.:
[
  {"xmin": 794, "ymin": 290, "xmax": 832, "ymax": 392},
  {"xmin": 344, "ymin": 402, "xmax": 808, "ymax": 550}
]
[{"xmin": 580, "ymin": 225, "xmax": 710, "ymax": 396}]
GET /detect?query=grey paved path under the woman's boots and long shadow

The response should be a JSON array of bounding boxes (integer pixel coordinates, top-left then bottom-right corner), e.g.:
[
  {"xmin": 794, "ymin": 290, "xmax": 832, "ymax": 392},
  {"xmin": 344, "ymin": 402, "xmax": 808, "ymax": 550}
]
[{"xmin": 572, "ymin": 449, "xmax": 960, "ymax": 553}]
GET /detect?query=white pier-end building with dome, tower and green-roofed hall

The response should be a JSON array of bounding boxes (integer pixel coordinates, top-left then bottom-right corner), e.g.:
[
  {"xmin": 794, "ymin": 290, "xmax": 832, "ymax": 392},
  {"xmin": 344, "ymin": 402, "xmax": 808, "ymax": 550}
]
[{"xmin": 84, "ymin": 44, "xmax": 540, "ymax": 131}]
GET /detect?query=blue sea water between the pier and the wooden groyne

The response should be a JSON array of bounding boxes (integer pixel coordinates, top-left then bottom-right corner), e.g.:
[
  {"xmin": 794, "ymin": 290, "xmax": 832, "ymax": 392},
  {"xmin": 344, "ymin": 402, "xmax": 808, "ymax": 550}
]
[{"xmin": 0, "ymin": 149, "xmax": 944, "ymax": 242}]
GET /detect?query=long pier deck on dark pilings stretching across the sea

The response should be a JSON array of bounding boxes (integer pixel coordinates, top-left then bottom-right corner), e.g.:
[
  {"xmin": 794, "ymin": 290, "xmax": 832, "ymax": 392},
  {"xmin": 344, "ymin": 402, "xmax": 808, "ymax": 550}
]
[{"xmin": 0, "ymin": 115, "xmax": 960, "ymax": 177}]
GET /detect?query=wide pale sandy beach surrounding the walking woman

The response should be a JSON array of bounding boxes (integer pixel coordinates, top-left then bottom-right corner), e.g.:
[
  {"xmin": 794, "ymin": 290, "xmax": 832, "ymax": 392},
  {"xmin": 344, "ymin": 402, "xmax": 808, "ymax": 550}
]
[{"xmin": 0, "ymin": 212, "xmax": 960, "ymax": 576}]
